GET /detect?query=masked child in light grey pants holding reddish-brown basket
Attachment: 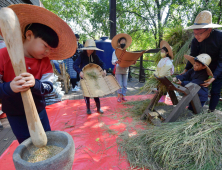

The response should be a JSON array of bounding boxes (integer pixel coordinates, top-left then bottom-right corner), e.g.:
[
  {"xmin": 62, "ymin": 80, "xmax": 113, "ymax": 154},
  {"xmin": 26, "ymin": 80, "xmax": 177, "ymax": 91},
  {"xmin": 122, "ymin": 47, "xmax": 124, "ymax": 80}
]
[{"xmin": 111, "ymin": 33, "xmax": 132, "ymax": 102}]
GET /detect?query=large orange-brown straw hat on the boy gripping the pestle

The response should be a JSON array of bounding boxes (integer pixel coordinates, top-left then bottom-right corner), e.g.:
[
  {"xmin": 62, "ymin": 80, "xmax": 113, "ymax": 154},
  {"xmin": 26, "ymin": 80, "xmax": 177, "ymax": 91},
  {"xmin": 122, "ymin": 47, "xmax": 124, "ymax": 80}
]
[{"xmin": 0, "ymin": 4, "xmax": 77, "ymax": 60}]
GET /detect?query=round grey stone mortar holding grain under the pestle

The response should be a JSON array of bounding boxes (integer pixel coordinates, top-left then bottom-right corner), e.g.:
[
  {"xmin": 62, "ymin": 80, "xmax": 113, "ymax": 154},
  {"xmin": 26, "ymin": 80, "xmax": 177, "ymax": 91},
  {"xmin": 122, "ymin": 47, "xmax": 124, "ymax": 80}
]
[{"xmin": 13, "ymin": 131, "xmax": 75, "ymax": 170}]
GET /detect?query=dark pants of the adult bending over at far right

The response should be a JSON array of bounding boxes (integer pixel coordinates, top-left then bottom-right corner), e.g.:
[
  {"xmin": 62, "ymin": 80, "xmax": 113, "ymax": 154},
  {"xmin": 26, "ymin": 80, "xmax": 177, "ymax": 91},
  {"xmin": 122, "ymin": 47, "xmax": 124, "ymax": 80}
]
[{"xmin": 209, "ymin": 77, "xmax": 222, "ymax": 110}]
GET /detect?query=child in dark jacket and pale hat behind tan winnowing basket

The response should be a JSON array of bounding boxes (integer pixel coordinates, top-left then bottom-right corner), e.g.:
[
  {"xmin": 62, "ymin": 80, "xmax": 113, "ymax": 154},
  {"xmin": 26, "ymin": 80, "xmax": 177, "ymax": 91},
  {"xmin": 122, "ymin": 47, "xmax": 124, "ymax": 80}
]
[{"xmin": 73, "ymin": 39, "xmax": 106, "ymax": 114}]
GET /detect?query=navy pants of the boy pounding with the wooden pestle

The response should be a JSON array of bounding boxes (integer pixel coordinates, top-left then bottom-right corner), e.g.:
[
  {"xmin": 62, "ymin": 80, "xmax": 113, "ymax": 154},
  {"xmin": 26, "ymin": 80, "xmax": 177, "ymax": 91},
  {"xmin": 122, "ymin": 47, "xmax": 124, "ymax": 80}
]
[{"xmin": 7, "ymin": 109, "xmax": 51, "ymax": 143}]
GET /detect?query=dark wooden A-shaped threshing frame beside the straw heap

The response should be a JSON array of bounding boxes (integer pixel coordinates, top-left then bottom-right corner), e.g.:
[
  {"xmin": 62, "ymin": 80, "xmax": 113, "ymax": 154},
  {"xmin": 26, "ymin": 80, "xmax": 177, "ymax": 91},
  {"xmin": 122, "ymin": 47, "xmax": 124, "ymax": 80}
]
[{"xmin": 141, "ymin": 77, "xmax": 202, "ymax": 122}]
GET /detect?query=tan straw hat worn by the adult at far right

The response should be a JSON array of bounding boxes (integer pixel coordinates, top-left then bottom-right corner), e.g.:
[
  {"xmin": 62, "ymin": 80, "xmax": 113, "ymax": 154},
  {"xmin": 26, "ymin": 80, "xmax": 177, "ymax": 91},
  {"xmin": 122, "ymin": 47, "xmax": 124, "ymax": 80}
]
[{"xmin": 185, "ymin": 10, "xmax": 222, "ymax": 29}]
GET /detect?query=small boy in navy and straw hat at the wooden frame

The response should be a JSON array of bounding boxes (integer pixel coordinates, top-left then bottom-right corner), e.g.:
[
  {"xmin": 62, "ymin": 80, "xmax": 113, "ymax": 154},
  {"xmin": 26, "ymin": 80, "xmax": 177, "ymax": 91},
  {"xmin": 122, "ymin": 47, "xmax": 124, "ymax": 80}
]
[{"xmin": 173, "ymin": 54, "xmax": 213, "ymax": 111}]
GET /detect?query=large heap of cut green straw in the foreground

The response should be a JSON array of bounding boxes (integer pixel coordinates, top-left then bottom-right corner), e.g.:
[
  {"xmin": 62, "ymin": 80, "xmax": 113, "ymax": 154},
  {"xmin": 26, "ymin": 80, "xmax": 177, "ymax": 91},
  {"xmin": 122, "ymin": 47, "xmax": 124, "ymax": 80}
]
[{"xmin": 118, "ymin": 113, "xmax": 222, "ymax": 170}]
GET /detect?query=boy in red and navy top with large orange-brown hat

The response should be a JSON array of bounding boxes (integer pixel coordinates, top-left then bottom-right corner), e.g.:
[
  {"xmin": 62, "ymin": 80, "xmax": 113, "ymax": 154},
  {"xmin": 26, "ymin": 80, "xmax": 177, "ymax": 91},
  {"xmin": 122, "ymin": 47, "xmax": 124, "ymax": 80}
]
[{"xmin": 0, "ymin": 4, "xmax": 76, "ymax": 143}]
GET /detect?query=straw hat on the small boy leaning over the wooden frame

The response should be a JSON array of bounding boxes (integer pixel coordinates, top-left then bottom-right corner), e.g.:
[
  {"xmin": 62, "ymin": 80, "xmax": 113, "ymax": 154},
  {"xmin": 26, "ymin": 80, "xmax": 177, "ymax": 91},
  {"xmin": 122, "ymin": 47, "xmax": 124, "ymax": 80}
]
[{"xmin": 184, "ymin": 53, "xmax": 213, "ymax": 77}]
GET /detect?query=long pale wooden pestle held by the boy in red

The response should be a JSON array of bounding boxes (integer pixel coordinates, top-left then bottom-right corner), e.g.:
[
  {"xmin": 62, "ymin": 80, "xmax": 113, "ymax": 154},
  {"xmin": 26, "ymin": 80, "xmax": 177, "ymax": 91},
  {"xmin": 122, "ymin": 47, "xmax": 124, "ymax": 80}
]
[{"xmin": 0, "ymin": 8, "xmax": 47, "ymax": 147}]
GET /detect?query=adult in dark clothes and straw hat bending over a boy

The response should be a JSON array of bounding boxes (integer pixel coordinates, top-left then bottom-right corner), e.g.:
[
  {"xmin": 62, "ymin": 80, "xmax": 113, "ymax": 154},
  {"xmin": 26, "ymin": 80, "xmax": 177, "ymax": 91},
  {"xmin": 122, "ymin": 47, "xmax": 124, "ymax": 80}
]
[{"xmin": 182, "ymin": 11, "xmax": 222, "ymax": 112}]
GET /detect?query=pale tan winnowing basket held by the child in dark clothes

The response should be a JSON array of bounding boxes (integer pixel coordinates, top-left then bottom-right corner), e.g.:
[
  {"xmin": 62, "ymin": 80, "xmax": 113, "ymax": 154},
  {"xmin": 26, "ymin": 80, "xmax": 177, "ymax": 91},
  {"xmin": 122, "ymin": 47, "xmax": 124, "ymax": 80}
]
[{"xmin": 80, "ymin": 64, "xmax": 120, "ymax": 97}]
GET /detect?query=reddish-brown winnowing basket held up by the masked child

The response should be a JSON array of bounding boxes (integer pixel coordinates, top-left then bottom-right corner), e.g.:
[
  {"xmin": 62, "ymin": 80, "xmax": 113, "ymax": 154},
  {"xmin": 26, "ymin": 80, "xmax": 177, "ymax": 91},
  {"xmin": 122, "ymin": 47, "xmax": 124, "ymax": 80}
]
[{"xmin": 115, "ymin": 48, "xmax": 146, "ymax": 67}]
